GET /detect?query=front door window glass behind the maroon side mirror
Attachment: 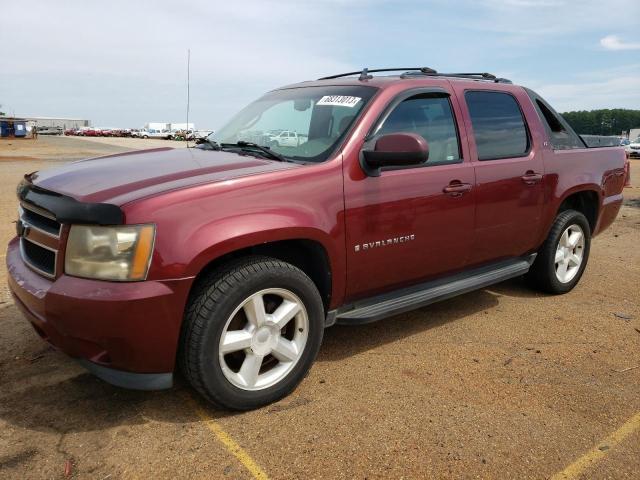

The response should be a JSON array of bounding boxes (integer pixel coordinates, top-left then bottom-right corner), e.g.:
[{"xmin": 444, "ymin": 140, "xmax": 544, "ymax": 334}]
[{"xmin": 376, "ymin": 94, "xmax": 460, "ymax": 165}]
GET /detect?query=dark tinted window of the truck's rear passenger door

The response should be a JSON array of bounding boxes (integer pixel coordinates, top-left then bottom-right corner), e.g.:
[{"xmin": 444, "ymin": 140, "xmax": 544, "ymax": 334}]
[{"xmin": 465, "ymin": 91, "xmax": 529, "ymax": 160}]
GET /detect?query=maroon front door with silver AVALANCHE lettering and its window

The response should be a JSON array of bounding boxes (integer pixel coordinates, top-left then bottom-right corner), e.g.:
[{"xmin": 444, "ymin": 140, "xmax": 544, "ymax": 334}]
[{"xmin": 345, "ymin": 89, "xmax": 475, "ymax": 300}]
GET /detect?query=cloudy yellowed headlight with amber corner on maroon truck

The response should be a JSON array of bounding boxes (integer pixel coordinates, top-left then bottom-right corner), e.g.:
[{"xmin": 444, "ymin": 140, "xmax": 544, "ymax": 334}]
[{"xmin": 64, "ymin": 225, "xmax": 155, "ymax": 281}]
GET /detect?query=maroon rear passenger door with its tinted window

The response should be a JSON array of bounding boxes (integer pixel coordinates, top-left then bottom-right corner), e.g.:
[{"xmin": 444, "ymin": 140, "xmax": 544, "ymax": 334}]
[{"xmin": 452, "ymin": 87, "xmax": 544, "ymax": 265}]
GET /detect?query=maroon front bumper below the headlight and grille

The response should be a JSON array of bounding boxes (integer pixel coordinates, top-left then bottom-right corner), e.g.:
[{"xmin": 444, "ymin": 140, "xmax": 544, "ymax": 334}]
[{"xmin": 6, "ymin": 239, "xmax": 193, "ymax": 390}]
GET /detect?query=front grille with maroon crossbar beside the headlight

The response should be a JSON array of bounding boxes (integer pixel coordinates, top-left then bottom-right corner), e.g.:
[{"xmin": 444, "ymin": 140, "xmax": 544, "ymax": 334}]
[{"xmin": 18, "ymin": 203, "xmax": 62, "ymax": 278}]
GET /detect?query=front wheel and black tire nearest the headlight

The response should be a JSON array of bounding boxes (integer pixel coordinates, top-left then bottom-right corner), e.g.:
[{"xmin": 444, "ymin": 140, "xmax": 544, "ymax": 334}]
[{"xmin": 179, "ymin": 256, "xmax": 324, "ymax": 410}]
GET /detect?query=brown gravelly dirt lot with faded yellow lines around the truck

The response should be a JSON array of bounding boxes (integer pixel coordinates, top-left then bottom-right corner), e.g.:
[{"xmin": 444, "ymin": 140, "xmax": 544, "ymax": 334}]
[{"xmin": 0, "ymin": 137, "xmax": 640, "ymax": 479}]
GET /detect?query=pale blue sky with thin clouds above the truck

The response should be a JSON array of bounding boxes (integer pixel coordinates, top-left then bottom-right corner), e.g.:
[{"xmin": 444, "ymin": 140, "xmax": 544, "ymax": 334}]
[{"xmin": 0, "ymin": 0, "xmax": 640, "ymax": 129}]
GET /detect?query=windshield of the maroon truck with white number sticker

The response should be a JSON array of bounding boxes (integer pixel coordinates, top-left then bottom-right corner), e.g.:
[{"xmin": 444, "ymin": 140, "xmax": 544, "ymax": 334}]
[{"xmin": 208, "ymin": 86, "xmax": 376, "ymax": 162}]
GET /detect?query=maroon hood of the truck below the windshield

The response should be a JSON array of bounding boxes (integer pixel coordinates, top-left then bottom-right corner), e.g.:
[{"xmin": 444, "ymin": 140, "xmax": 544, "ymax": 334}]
[{"xmin": 30, "ymin": 148, "xmax": 300, "ymax": 205}]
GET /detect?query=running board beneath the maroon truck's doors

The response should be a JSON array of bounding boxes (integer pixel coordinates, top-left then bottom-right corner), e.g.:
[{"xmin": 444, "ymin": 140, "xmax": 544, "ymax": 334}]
[{"xmin": 329, "ymin": 253, "xmax": 536, "ymax": 325}]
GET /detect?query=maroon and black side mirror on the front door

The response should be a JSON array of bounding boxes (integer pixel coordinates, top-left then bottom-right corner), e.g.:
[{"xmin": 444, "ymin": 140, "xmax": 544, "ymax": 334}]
[{"xmin": 361, "ymin": 132, "xmax": 429, "ymax": 177}]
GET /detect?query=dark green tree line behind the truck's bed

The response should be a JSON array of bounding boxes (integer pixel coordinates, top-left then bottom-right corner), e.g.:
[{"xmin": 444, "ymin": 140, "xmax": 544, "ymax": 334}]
[{"xmin": 562, "ymin": 108, "xmax": 640, "ymax": 135}]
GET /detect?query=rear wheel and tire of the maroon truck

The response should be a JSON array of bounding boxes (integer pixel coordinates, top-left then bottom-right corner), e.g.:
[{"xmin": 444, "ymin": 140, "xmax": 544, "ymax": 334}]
[{"xmin": 527, "ymin": 210, "xmax": 591, "ymax": 295}]
